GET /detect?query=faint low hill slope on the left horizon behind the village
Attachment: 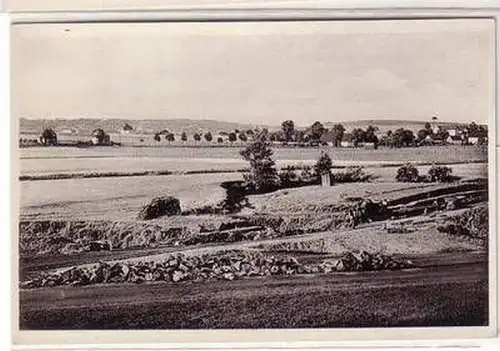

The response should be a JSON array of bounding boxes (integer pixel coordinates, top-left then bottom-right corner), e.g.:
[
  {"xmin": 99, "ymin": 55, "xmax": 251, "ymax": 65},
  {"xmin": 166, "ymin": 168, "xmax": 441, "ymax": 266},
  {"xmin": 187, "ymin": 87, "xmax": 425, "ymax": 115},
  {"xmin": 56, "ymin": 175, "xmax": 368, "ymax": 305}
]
[{"xmin": 19, "ymin": 118, "xmax": 272, "ymax": 135}]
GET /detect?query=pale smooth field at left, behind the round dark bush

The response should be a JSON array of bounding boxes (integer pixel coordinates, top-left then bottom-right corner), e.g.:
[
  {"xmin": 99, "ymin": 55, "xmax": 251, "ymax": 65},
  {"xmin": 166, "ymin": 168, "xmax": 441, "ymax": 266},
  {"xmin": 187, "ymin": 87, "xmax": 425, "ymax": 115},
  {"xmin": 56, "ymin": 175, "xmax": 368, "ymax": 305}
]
[{"xmin": 21, "ymin": 174, "xmax": 236, "ymax": 220}]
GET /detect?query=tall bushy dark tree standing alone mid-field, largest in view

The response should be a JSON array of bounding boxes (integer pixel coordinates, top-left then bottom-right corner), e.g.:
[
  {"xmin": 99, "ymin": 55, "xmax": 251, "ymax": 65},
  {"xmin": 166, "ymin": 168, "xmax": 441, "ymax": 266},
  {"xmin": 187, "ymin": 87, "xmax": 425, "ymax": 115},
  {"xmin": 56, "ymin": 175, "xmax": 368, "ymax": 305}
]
[{"xmin": 240, "ymin": 139, "xmax": 279, "ymax": 192}]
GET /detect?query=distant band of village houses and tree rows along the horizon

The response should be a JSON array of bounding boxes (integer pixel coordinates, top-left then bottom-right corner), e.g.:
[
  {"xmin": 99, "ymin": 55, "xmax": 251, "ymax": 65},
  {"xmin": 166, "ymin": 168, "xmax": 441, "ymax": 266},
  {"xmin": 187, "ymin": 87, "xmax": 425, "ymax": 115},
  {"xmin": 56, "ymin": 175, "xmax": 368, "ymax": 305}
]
[{"xmin": 19, "ymin": 117, "xmax": 488, "ymax": 149}]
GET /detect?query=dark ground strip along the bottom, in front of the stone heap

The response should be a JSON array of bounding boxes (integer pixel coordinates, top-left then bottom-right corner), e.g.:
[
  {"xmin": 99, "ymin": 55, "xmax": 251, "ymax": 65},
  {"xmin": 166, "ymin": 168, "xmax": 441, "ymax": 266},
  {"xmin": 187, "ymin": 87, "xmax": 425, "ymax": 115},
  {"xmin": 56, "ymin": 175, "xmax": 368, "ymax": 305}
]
[{"xmin": 20, "ymin": 254, "xmax": 488, "ymax": 329}]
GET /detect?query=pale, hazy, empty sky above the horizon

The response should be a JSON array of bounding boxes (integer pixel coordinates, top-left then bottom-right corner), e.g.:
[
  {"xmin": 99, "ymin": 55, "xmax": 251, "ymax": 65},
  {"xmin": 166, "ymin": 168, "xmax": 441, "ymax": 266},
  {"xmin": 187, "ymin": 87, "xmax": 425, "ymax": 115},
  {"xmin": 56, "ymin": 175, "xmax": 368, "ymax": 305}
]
[{"xmin": 11, "ymin": 19, "xmax": 494, "ymax": 126}]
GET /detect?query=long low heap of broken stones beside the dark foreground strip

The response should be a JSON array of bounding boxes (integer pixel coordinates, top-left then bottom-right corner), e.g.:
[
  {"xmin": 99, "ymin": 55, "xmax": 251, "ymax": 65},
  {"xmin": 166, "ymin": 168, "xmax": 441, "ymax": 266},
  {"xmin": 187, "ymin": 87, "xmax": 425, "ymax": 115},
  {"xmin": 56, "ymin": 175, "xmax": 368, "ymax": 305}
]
[{"xmin": 21, "ymin": 250, "xmax": 411, "ymax": 289}]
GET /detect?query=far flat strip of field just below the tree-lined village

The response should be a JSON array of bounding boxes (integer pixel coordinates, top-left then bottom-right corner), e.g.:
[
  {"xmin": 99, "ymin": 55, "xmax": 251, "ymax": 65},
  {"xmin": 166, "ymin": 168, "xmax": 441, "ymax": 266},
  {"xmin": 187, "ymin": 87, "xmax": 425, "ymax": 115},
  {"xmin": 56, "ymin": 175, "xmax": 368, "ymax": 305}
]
[{"xmin": 20, "ymin": 146, "xmax": 487, "ymax": 175}]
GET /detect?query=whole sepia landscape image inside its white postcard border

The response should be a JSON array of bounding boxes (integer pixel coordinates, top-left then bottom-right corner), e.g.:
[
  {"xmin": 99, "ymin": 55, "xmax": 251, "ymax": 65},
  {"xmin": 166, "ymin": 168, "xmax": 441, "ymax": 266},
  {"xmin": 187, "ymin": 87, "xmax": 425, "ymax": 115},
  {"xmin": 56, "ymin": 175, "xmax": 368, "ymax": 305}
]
[{"xmin": 11, "ymin": 19, "xmax": 495, "ymax": 331}]
